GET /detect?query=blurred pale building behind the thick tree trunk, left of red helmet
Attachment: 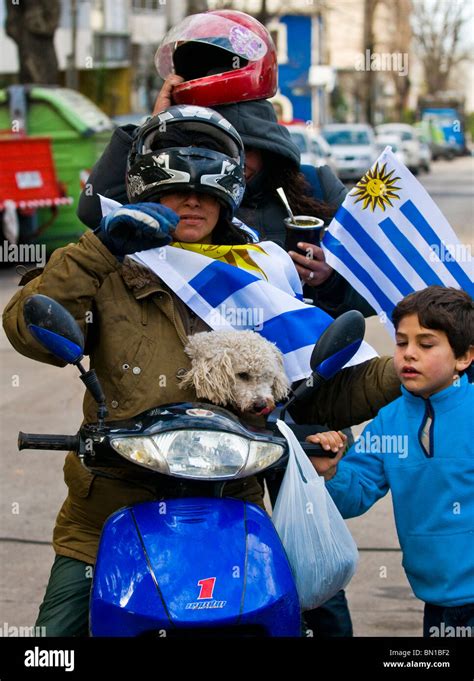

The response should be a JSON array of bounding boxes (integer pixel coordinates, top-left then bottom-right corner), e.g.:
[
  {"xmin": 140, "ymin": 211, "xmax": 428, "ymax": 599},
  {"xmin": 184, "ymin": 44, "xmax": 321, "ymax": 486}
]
[{"xmin": 0, "ymin": 0, "xmax": 187, "ymax": 116}]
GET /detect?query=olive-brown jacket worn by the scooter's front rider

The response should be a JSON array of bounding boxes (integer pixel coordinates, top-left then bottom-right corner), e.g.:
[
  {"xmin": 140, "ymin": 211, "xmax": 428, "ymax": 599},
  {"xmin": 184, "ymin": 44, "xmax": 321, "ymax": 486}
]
[{"xmin": 3, "ymin": 232, "xmax": 399, "ymax": 562}]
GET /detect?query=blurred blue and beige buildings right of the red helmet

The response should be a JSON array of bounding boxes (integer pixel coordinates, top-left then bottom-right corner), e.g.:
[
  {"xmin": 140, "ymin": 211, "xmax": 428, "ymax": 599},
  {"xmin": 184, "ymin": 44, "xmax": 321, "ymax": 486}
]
[{"xmin": 210, "ymin": 0, "xmax": 412, "ymax": 126}]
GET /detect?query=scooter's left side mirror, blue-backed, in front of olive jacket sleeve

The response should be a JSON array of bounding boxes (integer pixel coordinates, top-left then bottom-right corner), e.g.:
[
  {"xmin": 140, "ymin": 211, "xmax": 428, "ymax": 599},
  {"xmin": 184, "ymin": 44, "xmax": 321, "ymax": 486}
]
[{"xmin": 23, "ymin": 294, "xmax": 84, "ymax": 364}]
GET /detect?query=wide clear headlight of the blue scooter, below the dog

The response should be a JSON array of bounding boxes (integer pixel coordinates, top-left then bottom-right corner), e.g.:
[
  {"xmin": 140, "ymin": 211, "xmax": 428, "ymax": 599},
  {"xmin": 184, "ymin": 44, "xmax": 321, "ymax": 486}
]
[{"xmin": 110, "ymin": 430, "xmax": 284, "ymax": 480}]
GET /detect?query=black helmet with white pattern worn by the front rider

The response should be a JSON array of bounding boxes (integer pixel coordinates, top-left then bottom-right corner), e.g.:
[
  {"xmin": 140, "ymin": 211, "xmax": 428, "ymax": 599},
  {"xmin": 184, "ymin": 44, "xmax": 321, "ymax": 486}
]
[{"xmin": 126, "ymin": 105, "xmax": 245, "ymax": 216}]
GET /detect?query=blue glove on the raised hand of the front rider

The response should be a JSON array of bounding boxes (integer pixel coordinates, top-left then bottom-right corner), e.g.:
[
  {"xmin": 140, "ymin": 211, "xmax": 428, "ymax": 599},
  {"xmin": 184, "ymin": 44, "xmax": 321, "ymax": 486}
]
[{"xmin": 94, "ymin": 203, "xmax": 179, "ymax": 258}]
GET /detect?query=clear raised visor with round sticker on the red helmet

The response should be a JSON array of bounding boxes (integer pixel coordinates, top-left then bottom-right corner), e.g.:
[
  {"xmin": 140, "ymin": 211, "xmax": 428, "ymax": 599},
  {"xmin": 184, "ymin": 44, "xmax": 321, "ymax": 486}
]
[{"xmin": 155, "ymin": 14, "xmax": 268, "ymax": 78}]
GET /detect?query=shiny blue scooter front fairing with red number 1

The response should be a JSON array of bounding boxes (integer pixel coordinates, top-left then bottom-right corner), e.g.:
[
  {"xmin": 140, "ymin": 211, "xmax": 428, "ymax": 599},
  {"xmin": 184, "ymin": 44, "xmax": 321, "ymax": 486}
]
[{"xmin": 90, "ymin": 497, "xmax": 300, "ymax": 636}]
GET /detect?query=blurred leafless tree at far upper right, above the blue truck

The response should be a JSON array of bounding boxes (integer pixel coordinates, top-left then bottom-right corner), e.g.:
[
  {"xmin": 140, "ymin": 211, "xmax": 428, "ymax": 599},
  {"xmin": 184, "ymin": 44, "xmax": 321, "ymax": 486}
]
[{"xmin": 413, "ymin": 0, "xmax": 472, "ymax": 94}]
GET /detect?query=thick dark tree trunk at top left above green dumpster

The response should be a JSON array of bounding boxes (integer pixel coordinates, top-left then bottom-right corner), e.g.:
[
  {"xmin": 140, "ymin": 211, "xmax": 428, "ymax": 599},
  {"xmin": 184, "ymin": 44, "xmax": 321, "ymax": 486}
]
[{"xmin": 5, "ymin": 0, "xmax": 61, "ymax": 84}]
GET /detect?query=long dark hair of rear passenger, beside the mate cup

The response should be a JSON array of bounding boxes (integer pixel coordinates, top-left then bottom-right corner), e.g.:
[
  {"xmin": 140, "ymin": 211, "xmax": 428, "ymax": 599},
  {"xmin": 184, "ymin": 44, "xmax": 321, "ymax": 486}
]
[{"xmin": 262, "ymin": 151, "xmax": 337, "ymax": 220}]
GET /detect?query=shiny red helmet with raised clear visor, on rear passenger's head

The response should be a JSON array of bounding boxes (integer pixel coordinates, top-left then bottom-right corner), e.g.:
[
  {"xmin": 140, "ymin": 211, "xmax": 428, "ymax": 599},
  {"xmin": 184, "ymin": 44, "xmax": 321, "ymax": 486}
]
[{"xmin": 155, "ymin": 10, "xmax": 278, "ymax": 106}]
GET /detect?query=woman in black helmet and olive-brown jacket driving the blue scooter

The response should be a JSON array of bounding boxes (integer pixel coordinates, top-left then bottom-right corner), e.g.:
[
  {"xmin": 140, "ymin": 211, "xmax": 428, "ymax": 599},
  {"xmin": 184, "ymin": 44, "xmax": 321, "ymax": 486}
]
[{"xmin": 3, "ymin": 106, "xmax": 398, "ymax": 636}]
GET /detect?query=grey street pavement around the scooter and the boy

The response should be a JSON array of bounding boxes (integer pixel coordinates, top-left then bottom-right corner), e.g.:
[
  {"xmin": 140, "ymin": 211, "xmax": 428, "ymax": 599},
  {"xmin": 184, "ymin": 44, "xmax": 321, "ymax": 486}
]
[{"xmin": 0, "ymin": 158, "xmax": 474, "ymax": 636}]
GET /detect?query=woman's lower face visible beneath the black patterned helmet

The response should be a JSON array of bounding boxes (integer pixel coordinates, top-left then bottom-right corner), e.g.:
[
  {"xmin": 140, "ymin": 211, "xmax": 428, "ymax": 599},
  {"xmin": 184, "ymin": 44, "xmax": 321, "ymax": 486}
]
[{"xmin": 161, "ymin": 192, "xmax": 221, "ymax": 244}]
